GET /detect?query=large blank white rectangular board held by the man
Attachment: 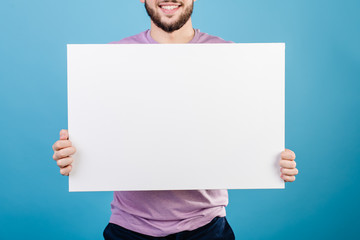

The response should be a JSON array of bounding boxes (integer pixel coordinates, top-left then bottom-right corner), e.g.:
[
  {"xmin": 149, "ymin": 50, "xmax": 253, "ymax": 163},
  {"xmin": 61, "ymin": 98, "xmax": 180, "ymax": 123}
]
[{"xmin": 68, "ymin": 43, "xmax": 285, "ymax": 191}]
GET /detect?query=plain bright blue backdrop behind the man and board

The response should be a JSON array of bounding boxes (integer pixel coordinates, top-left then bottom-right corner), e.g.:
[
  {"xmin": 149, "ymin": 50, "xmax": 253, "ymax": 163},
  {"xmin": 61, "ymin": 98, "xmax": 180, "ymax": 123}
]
[{"xmin": 0, "ymin": 0, "xmax": 360, "ymax": 240}]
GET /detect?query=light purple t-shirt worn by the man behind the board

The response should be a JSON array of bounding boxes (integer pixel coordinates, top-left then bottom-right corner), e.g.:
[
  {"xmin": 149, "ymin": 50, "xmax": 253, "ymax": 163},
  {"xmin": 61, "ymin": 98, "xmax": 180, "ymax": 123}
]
[{"xmin": 110, "ymin": 29, "xmax": 231, "ymax": 237}]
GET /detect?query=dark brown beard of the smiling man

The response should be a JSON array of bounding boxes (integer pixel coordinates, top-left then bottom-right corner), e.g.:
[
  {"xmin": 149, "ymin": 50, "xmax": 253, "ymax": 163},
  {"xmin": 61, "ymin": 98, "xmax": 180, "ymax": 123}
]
[{"xmin": 145, "ymin": 0, "xmax": 194, "ymax": 33}]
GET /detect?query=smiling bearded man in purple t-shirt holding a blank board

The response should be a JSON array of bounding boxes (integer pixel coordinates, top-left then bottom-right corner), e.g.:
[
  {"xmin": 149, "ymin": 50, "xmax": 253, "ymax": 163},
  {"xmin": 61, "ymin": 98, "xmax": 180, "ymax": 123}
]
[{"xmin": 53, "ymin": 0, "xmax": 298, "ymax": 240}]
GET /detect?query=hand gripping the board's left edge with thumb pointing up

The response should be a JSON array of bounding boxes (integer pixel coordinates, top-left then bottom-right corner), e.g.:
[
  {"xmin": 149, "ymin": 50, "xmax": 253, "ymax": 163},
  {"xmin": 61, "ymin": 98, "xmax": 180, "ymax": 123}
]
[{"xmin": 53, "ymin": 129, "xmax": 76, "ymax": 176}]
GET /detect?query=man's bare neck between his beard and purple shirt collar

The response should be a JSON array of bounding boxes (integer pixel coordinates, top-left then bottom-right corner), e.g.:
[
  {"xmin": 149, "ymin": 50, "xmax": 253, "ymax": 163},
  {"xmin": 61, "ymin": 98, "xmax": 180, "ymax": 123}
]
[{"xmin": 150, "ymin": 19, "xmax": 195, "ymax": 43}]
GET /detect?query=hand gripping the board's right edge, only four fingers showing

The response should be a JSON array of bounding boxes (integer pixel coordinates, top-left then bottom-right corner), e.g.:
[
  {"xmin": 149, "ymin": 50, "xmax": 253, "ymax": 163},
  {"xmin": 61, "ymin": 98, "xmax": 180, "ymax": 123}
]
[{"xmin": 280, "ymin": 149, "xmax": 299, "ymax": 182}]
